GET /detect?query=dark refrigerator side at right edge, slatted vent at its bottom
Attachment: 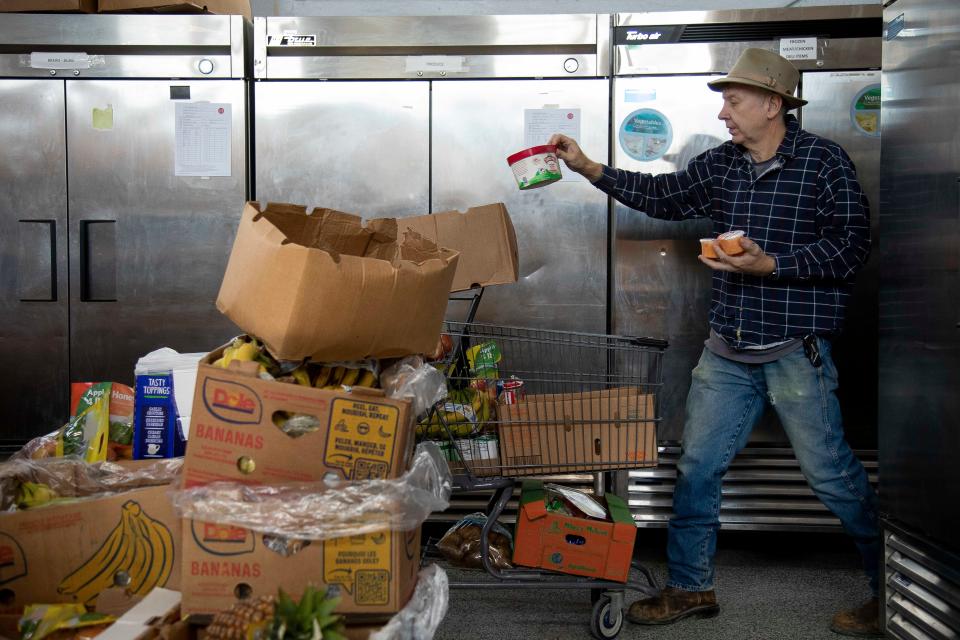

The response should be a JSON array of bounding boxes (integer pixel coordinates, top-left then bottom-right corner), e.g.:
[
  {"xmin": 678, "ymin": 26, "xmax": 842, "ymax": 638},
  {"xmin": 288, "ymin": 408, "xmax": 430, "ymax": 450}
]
[{"xmin": 879, "ymin": 0, "xmax": 960, "ymax": 639}]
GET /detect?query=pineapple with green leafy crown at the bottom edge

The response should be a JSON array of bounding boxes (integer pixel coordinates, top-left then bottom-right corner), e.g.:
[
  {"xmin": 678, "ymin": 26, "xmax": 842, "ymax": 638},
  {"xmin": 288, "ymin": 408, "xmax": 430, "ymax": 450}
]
[{"xmin": 205, "ymin": 587, "xmax": 346, "ymax": 640}]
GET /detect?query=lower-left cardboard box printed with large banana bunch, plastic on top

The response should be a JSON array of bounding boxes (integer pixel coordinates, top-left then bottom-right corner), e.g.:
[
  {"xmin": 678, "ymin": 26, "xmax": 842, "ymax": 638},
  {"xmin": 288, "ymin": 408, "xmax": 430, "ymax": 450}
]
[{"xmin": 0, "ymin": 458, "xmax": 181, "ymax": 606}]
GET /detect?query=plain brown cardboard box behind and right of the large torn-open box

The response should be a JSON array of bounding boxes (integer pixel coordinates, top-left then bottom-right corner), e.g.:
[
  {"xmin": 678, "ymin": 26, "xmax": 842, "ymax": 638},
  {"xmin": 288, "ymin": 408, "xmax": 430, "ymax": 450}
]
[{"xmin": 399, "ymin": 202, "xmax": 520, "ymax": 291}]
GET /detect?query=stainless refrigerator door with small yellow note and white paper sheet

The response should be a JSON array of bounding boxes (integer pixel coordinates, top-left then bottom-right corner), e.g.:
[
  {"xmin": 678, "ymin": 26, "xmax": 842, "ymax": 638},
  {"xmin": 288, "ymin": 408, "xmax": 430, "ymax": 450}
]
[{"xmin": 67, "ymin": 80, "xmax": 246, "ymax": 383}]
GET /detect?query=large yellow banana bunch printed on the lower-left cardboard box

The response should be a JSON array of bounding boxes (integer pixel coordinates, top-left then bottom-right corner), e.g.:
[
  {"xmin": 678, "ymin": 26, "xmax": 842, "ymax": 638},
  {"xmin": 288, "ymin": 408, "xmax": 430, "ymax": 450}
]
[{"xmin": 57, "ymin": 500, "xmax": 174, "ymax": 605}]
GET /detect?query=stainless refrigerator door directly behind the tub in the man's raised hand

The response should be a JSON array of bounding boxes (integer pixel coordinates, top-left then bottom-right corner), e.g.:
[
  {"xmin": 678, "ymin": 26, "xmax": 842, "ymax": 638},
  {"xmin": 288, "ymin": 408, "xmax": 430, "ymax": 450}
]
[{"xmin": 431, "ymin": 79, "xmax": 609, "ymax": 333}]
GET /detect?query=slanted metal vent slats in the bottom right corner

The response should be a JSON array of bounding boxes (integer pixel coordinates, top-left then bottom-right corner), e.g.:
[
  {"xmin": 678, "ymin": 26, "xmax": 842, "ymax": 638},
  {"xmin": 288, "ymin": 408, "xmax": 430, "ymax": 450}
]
[{"xmin": 883, "ymin": 531, "xmax": 960, "ymax": 640}]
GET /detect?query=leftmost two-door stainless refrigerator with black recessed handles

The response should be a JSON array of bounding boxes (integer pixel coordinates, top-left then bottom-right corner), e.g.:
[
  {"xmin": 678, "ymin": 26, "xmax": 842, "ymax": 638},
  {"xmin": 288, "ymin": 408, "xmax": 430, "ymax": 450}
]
[{"xmin": 0, "ymin": 14, "xmax": 249, "ymax": 446}]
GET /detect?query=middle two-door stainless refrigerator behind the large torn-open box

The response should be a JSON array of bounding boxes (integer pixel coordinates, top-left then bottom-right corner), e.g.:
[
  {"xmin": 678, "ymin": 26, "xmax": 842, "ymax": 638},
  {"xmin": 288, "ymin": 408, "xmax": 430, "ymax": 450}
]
[{"xmin": 253, "ymin": 14, "xmax": 609, "ymax": 332}]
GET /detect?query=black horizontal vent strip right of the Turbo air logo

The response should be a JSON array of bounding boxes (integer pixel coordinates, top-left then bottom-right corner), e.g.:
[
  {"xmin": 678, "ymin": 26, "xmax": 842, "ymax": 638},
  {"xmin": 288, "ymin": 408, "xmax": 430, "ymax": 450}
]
[{"xmin": 679, "ymin": 17, "xmax": 883, "ymax": 42}]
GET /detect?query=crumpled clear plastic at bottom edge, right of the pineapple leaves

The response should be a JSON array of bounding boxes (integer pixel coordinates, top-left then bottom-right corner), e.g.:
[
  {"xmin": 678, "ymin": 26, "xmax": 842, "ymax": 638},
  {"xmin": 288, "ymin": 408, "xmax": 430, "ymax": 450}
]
[{"xmin": 370, "ymin": 565, "xmax": 450, "ymax": 640}]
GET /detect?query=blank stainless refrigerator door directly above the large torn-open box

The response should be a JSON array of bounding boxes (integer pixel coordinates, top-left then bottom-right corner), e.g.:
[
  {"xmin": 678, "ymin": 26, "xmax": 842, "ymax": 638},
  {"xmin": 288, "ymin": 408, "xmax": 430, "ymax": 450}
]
[{"xmin": 254, "ymin": 81, "xmax": 430, "ymax": 218}]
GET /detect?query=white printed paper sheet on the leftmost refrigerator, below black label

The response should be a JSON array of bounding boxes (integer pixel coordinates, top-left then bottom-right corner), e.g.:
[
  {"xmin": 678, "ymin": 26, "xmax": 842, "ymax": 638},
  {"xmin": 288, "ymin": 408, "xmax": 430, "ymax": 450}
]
[{"xmin": 173, "ymin": 102, "xmax": 233, "ymax": 176}]
